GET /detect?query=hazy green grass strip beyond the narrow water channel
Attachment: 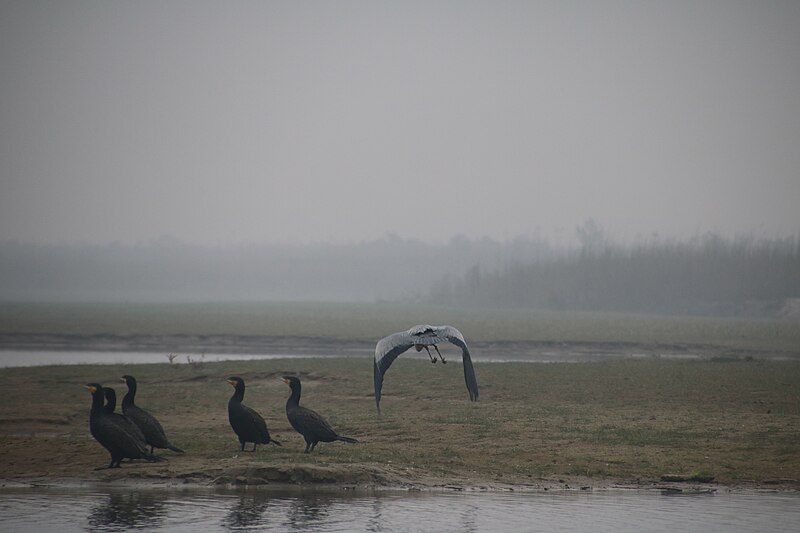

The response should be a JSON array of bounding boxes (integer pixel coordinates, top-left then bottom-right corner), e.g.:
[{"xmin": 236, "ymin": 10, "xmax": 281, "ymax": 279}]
[{"xmin": 0, "ymin": 303, "xmax": 800, "ymax": 354}]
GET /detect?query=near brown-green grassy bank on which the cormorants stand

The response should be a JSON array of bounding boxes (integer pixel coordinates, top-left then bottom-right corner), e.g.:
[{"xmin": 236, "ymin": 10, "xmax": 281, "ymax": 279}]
[{"xmin": 0, "ymin": 355, "xmax": 800, "ymax": 487}]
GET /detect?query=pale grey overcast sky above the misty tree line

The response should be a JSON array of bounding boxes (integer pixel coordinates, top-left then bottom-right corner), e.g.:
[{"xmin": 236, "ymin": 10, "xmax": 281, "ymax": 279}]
[{"xmin": 0, "ymin": 0, "xmax": 800, "ymax": 244}]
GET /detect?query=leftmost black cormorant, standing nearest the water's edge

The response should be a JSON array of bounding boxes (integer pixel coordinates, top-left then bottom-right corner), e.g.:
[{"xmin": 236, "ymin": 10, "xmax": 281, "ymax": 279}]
[{"xmin": 86, "ymin": 383, "xmax": 164, "ymax": 468}]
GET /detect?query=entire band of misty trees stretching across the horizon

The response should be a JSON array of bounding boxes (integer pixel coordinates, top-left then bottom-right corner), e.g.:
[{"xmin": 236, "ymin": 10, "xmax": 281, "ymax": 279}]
[{"xmin": 0, "ymin": 224, "xmax": 800, "ymax": 316}]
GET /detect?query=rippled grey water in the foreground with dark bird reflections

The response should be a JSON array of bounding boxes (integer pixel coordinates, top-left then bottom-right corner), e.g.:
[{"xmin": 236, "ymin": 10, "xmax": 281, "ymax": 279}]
[{"xmin": 0, "ymin": 487, "xmax": 800, "ymax": 533}]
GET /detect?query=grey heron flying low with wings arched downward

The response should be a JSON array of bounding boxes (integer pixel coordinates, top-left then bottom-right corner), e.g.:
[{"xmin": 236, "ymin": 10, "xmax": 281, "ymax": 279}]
[{"xmin": 373, "ymin": 325, "xmax": 478, "ymax": 413}]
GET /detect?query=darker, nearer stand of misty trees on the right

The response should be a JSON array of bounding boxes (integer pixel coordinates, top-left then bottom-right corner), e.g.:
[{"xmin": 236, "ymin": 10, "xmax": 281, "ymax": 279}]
[{"xmin": 430, "ymin": 229, "xmax": 800, "ymax": 316}]
